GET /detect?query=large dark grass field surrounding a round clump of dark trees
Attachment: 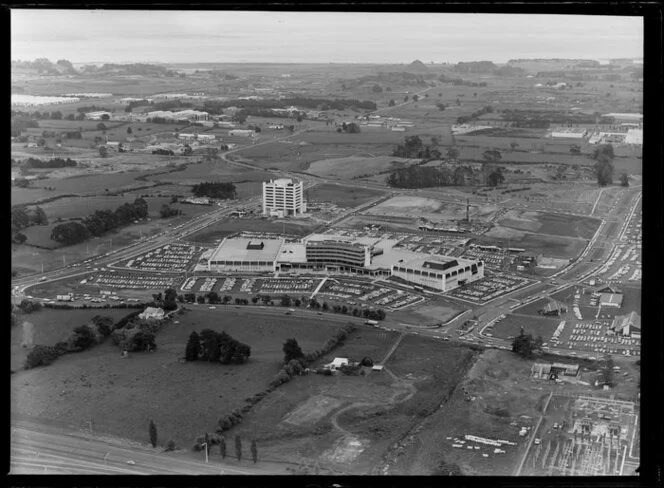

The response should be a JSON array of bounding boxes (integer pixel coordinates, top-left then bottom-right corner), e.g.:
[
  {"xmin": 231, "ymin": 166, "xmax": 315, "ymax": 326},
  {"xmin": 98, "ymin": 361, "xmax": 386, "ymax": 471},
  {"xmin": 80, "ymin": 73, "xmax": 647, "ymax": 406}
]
[{"xmin": 11, "ymin": 310, "xmax": 352, "ymax": 449}]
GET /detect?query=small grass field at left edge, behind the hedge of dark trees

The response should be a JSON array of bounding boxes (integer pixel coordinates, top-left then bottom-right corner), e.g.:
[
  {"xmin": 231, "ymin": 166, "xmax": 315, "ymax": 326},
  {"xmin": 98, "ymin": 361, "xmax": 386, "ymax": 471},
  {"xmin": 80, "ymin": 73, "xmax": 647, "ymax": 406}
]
[{"xmin": 11, "ymin": 309, "xmax": 132, "ymax": 371}]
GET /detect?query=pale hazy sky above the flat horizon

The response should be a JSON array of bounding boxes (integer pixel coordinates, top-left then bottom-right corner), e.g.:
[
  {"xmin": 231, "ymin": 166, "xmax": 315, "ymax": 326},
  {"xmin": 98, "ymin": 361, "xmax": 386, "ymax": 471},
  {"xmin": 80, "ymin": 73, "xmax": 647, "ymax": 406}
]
[{"xmin": 11, "ymin": 9, "xmax": 643, "ymax": 64}]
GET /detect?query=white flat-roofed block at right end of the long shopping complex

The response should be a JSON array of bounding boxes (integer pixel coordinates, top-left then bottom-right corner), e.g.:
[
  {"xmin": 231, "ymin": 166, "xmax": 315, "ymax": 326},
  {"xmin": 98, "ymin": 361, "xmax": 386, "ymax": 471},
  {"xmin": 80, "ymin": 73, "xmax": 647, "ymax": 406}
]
[{"xmin": 392, "ymin": 255, "xmax": 484, "ymax": 291}]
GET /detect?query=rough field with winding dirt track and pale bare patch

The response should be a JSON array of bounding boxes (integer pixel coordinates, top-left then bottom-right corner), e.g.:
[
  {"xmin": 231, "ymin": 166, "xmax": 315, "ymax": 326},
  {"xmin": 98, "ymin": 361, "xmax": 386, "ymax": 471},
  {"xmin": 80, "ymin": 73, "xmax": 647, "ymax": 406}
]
[{"xmin": 223, "ymin": 330, "xmax": 473, "ymax": 474}]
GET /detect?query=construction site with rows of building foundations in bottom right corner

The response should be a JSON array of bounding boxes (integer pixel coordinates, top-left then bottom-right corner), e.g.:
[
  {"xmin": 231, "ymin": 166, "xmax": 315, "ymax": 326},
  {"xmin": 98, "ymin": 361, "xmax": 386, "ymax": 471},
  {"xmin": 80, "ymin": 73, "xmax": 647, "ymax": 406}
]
[{"xmin": 520, "ymin": 395, "xmax": 639, "ymax": 476}]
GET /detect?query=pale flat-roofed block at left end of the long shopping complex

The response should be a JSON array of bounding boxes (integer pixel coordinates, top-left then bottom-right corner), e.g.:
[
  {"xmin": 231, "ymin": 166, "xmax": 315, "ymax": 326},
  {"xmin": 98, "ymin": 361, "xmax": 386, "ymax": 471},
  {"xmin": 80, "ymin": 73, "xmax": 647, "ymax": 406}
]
[{"xmin": 208, "ymin": 237, "xmax": 285, "ymax": 272}]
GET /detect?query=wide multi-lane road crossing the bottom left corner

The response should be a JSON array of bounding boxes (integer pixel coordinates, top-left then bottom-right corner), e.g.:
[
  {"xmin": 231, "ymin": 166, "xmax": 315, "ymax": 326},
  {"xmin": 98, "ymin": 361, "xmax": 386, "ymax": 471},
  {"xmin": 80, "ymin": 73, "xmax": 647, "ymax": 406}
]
[{"xmin": 10, "ymin": 421, "xmax": 270, "ymax": 475}]
